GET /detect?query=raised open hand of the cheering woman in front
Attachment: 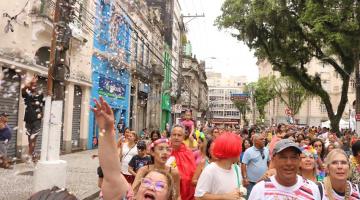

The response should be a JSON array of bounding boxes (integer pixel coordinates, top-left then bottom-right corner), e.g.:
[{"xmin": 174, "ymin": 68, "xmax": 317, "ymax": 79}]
[{"xmin": 91, "ymin": 96, "xmax": 115, "ymax": 133}]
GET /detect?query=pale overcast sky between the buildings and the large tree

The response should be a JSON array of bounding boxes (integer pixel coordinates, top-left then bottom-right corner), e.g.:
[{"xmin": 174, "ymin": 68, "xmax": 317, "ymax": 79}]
[{"xmin": 179, "ymin": 0, "xmax": 259, "ymax": 82}]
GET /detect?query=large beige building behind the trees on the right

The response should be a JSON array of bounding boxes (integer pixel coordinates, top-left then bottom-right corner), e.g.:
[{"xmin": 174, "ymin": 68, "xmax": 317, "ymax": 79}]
[{"xmin": 258, "ymin": 59, "xmax": 355, "ymax": 126}]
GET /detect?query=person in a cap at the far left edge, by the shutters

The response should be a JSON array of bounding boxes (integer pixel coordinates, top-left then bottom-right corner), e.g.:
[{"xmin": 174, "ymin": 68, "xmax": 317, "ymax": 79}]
[{"xmin": 0, "ymin": 113, "xmax": 11, "ymax": 168}]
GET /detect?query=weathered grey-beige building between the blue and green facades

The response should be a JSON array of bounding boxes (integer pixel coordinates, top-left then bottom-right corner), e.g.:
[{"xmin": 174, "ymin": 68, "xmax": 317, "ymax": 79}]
[{"xmin": 120, "ymin": 0, "xmax": 164, "ymax": 132}]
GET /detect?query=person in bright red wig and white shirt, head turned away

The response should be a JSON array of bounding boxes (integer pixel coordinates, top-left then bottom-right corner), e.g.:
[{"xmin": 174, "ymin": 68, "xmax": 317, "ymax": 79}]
[{"xmin": 195, "ymin": 133, "xmax": 246, "ymax": 200}]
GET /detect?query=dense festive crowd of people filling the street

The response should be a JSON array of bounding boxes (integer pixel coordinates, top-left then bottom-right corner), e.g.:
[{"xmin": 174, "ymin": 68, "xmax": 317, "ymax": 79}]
[{"xmin": 86, "ymin": 98, "xmax": 360, "ymax": 200}]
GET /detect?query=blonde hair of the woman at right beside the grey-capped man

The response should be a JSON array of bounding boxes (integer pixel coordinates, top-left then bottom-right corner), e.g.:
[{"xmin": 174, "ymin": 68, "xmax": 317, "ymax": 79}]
[{"xmin": 324, "ymin": 148, "xmax": 351, "ymax": 200}]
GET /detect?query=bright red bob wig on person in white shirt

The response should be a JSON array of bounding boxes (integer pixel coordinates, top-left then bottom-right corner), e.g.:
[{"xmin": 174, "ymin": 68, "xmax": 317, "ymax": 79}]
[{"xmin": 212, "ymin": 132, "xmax": 242, "ymax": 159}]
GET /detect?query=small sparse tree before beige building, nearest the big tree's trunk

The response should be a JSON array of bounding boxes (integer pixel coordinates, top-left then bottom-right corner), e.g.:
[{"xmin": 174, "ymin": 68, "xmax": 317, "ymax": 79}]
[{"xmin": 274, "ymin": 76, "xmax": 311, "ymax": 115}]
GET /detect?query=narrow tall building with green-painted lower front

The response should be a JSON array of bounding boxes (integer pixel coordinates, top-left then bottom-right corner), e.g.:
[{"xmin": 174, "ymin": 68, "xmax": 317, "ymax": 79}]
[{"xmin": 146, "ymin": 0, "xmax": 185, "ymax": 130}]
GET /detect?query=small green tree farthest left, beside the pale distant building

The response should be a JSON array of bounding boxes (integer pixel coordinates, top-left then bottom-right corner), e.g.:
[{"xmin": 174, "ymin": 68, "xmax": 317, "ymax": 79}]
[{"xmin": 248, "ymin": 76, "xmax": 275, "ymax": 122}]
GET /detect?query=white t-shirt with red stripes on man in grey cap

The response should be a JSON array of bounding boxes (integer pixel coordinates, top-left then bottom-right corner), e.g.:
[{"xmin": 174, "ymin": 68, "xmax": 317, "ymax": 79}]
[{"xmin": 249, "ymin": 176, "xmax": 320, "ymax": 200}]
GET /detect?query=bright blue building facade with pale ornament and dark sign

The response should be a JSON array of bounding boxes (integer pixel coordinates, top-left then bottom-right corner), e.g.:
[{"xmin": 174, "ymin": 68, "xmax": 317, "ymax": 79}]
[{"xmin": 87, "ymin": 1, "xmax": 132, "ymax": 149}]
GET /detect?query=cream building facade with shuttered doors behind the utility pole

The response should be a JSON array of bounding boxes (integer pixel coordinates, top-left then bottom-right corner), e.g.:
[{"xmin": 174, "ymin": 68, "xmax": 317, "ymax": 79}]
[{"xmin": 0, "ymin": 0, "xmax": 94, "ymax": 157}]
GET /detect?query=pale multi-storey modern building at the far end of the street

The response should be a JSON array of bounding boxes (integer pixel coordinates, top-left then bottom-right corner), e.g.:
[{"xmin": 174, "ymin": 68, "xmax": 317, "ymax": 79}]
[{"xmin": 206, "ymin": 72, "xmax": 247, "ymax": 126}]
